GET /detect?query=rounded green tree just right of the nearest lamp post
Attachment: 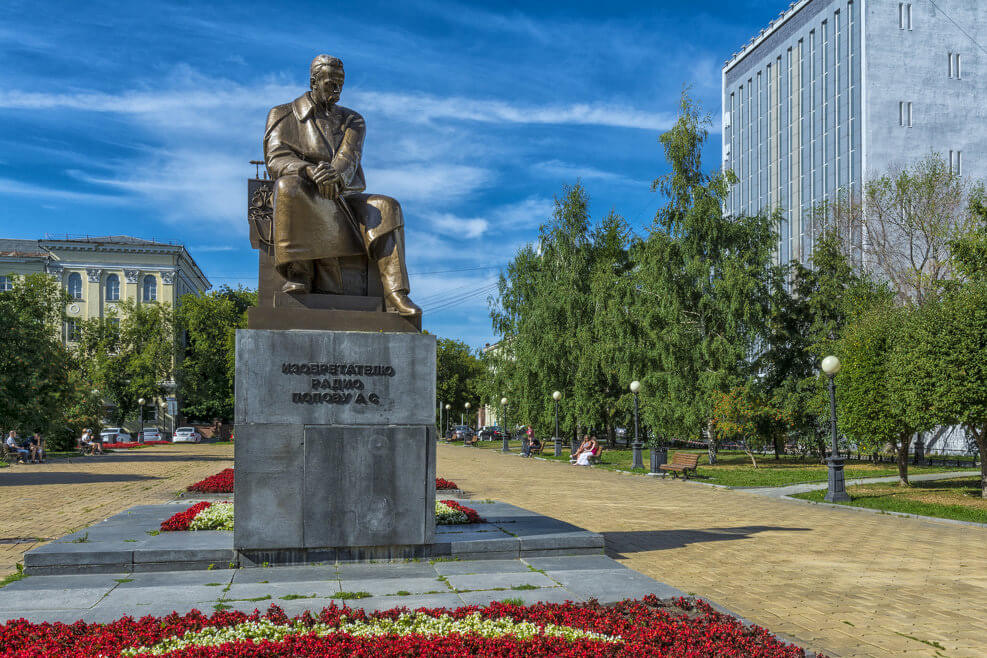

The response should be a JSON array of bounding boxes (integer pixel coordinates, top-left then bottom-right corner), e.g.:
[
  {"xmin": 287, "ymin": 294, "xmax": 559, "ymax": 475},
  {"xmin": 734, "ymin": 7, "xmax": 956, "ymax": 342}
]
[{"xmin": 836, "ymin": 305, "xmax": 926, "ymax": 486}]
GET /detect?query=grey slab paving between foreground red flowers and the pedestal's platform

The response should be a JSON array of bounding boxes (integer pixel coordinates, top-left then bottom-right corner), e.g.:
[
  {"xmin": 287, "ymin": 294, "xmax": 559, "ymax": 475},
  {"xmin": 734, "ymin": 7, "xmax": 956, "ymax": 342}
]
[{"xmin": 0, "ymin": 555, "xmax": 685, "ymax": 623}]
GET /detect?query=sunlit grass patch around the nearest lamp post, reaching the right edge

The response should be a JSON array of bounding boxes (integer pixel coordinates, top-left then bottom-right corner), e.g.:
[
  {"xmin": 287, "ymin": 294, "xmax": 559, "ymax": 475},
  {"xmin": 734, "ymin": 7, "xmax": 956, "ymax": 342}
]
[{"xmin": 793, "ymin": 477, "xmax": 987, "ymax": 523}]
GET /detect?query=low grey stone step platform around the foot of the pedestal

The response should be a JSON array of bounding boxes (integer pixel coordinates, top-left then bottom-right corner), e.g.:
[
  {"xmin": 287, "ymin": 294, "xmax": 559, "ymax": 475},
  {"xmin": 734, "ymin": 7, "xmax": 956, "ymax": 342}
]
[{"xmin": 24, "ymin": 496, "xmax": 604, "ymax": 575}]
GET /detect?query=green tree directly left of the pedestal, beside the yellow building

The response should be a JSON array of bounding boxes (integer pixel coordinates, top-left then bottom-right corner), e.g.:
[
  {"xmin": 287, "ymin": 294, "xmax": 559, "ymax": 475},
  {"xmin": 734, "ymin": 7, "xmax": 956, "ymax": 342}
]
[{"xmin": 175, "ymin": 286, "xmax": 257, "ymax": 422}]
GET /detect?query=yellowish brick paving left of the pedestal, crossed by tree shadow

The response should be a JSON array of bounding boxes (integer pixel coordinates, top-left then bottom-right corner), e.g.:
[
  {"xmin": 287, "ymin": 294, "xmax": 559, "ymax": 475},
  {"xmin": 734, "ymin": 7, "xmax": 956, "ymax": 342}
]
[{"xmin": 0, "ymin": 443, "xmax": 233, "ymax": 578}]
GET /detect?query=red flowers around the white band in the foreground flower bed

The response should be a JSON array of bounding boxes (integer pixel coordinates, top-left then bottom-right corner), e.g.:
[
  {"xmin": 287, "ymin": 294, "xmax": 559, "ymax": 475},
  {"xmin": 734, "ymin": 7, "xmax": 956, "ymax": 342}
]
[{"xmin": 0, "ymin": 596, "xmax": 824, "ymax": 658}]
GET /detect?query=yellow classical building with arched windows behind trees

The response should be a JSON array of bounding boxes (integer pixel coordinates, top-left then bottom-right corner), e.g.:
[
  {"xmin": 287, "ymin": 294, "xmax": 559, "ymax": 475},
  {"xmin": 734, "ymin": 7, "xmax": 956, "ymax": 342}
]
[{"xmin": 0, "ymin": 235, "xmax": 211, "ymax": 425}]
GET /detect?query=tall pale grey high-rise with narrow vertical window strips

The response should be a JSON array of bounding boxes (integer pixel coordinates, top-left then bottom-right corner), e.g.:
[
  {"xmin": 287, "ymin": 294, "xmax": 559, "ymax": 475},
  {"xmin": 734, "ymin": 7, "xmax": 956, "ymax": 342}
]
[{"xmin": 722, "ymin": 0, "xmax": 987, "ymax": 263}]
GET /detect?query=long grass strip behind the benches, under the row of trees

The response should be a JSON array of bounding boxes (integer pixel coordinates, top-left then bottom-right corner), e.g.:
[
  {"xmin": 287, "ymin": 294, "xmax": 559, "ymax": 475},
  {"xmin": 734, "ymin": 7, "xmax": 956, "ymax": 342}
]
[{"xmin": 454, "ymin": 441, "xmax": 972, "ymax": 487}]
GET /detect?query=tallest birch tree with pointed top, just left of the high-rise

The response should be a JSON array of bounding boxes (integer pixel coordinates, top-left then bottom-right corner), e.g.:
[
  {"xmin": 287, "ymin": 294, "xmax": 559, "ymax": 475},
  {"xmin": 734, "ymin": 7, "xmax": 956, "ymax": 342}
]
[{"xmin": 632, "ymin": 94, "xmax": 775, "ymax": 462}]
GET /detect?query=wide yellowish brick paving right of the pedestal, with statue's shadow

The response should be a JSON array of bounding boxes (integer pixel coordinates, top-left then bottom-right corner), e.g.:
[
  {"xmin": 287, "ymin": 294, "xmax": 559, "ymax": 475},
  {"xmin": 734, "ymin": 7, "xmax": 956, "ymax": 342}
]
[{"xmin": 438, "ymin": 445, "xmax": 987, "ymax": 658}]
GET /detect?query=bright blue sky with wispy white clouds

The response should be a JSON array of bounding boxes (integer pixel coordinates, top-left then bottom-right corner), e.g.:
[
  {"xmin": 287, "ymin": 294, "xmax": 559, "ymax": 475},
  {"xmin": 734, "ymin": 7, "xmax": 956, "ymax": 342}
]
[{"xmin": 0, "ymin": 0, "xmax": 788, "ymax": 346}]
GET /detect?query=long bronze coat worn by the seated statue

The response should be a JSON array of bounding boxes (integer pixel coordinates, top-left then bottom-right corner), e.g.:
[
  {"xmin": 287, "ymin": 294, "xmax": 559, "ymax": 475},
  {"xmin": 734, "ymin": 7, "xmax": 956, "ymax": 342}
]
[{"xmin": 264, "ymin": 93, "xmax": 404, "ymax": 266}]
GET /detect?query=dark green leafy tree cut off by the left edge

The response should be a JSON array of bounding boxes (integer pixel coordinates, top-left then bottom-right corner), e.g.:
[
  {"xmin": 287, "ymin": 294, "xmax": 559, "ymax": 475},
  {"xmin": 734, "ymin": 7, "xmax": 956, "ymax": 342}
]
[{"xmin": 0, "ymin": 274, "xmax": 77, "ymax": 448}]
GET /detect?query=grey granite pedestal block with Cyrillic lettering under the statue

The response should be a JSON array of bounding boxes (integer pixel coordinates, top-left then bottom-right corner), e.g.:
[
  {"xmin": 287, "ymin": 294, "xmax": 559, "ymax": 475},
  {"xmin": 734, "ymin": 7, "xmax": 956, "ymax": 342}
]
[{"xmin": 233, "ymin": 329, "xmax": 435, "ymax": 564}]
